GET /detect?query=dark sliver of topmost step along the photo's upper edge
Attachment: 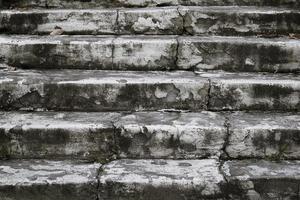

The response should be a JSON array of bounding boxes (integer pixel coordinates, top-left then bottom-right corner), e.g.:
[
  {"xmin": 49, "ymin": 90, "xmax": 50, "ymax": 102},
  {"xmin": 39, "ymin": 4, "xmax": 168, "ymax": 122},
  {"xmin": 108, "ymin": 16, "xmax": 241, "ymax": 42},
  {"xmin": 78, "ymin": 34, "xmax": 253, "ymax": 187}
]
[{"xmin": 3, "ymin": 0, "xmax": 300, "ymax": 9}]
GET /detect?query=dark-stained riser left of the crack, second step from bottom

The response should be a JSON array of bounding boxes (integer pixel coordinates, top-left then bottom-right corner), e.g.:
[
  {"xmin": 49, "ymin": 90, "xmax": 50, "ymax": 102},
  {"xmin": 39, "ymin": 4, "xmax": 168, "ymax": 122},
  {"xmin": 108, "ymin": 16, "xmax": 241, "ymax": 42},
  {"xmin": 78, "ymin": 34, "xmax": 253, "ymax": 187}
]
[{"xmin": 0, "ymin": 127, "xmax": 116, "ymax": 161}]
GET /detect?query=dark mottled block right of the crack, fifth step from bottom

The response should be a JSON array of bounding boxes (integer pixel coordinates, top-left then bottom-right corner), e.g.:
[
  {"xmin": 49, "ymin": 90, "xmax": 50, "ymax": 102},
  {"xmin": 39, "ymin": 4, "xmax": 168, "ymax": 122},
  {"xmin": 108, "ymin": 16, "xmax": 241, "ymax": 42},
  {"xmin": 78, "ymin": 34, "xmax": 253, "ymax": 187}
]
[{"xmin": 179, "ymin": 6, "xmax": 300, "ymax": 36}]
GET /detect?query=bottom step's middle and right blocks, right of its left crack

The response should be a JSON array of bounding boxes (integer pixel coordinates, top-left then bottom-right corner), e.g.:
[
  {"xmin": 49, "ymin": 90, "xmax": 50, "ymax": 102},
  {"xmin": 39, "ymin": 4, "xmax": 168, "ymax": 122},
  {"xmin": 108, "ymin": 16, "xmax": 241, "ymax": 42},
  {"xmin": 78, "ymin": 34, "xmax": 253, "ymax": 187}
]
[{"xmin": 99, "ymin": 159, "xmax": 300, "ymax": 200}]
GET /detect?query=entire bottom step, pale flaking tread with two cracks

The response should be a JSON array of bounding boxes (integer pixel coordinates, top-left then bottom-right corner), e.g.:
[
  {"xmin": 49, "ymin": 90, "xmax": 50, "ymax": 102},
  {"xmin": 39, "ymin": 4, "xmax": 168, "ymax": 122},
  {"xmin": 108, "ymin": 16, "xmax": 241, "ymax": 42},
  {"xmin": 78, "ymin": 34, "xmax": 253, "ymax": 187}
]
[{"xmin": 0, "ymin": 159, "xmax": 300, "ymax": 200}]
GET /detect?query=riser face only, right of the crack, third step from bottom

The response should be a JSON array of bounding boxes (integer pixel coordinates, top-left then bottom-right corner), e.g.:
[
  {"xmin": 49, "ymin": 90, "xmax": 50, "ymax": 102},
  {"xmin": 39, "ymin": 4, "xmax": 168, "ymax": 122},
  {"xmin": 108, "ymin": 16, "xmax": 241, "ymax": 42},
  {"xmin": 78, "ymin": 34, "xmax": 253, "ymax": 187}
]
[{"xmin": 209, "ymin": 80, "xmax": 300, "ymax": 111}]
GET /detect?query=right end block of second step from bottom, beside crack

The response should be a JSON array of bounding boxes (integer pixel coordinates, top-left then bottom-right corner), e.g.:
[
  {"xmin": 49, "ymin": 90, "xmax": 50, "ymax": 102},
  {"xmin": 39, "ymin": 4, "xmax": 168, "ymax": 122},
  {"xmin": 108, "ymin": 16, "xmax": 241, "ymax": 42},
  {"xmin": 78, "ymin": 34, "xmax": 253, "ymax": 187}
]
[{"xmin": 225, "ymin": 112, "xmax": 300, "ymax": 160}]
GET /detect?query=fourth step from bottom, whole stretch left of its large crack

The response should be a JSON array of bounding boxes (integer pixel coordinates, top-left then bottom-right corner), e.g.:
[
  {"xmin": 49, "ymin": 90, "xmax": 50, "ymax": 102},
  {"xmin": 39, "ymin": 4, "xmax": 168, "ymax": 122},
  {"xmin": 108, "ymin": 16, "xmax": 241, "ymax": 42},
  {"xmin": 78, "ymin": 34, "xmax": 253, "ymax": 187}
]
[{"xmin": 0, "ymin": 36, "xmax": 177, "ymax": 71}]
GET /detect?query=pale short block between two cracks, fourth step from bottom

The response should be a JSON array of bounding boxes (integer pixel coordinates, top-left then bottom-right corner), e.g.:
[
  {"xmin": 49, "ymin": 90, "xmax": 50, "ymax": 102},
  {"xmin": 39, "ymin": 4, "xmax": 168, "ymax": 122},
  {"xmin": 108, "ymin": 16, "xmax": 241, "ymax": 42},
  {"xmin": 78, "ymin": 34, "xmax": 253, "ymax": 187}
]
[{"xmin": 113, "ymin": 36, "xmax": 177, "ymax": 70}]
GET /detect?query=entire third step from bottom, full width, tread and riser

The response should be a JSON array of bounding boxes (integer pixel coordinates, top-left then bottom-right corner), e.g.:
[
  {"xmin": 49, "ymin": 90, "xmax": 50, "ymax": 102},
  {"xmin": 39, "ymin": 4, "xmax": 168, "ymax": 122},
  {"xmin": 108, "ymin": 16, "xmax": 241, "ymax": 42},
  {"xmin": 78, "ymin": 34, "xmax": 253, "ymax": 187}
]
[{"xmin": 0, "ymin": 70, "xmax": 300, "ymax": 111}]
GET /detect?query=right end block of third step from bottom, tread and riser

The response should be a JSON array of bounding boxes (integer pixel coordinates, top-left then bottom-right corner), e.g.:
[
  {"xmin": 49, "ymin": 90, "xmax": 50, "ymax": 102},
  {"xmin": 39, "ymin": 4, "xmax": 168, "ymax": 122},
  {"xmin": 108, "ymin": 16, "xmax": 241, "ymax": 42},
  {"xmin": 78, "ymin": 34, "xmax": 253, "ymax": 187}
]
[{"xmin": 199, "ymin": 72, "xmax": 300, "ymax": 111}]
